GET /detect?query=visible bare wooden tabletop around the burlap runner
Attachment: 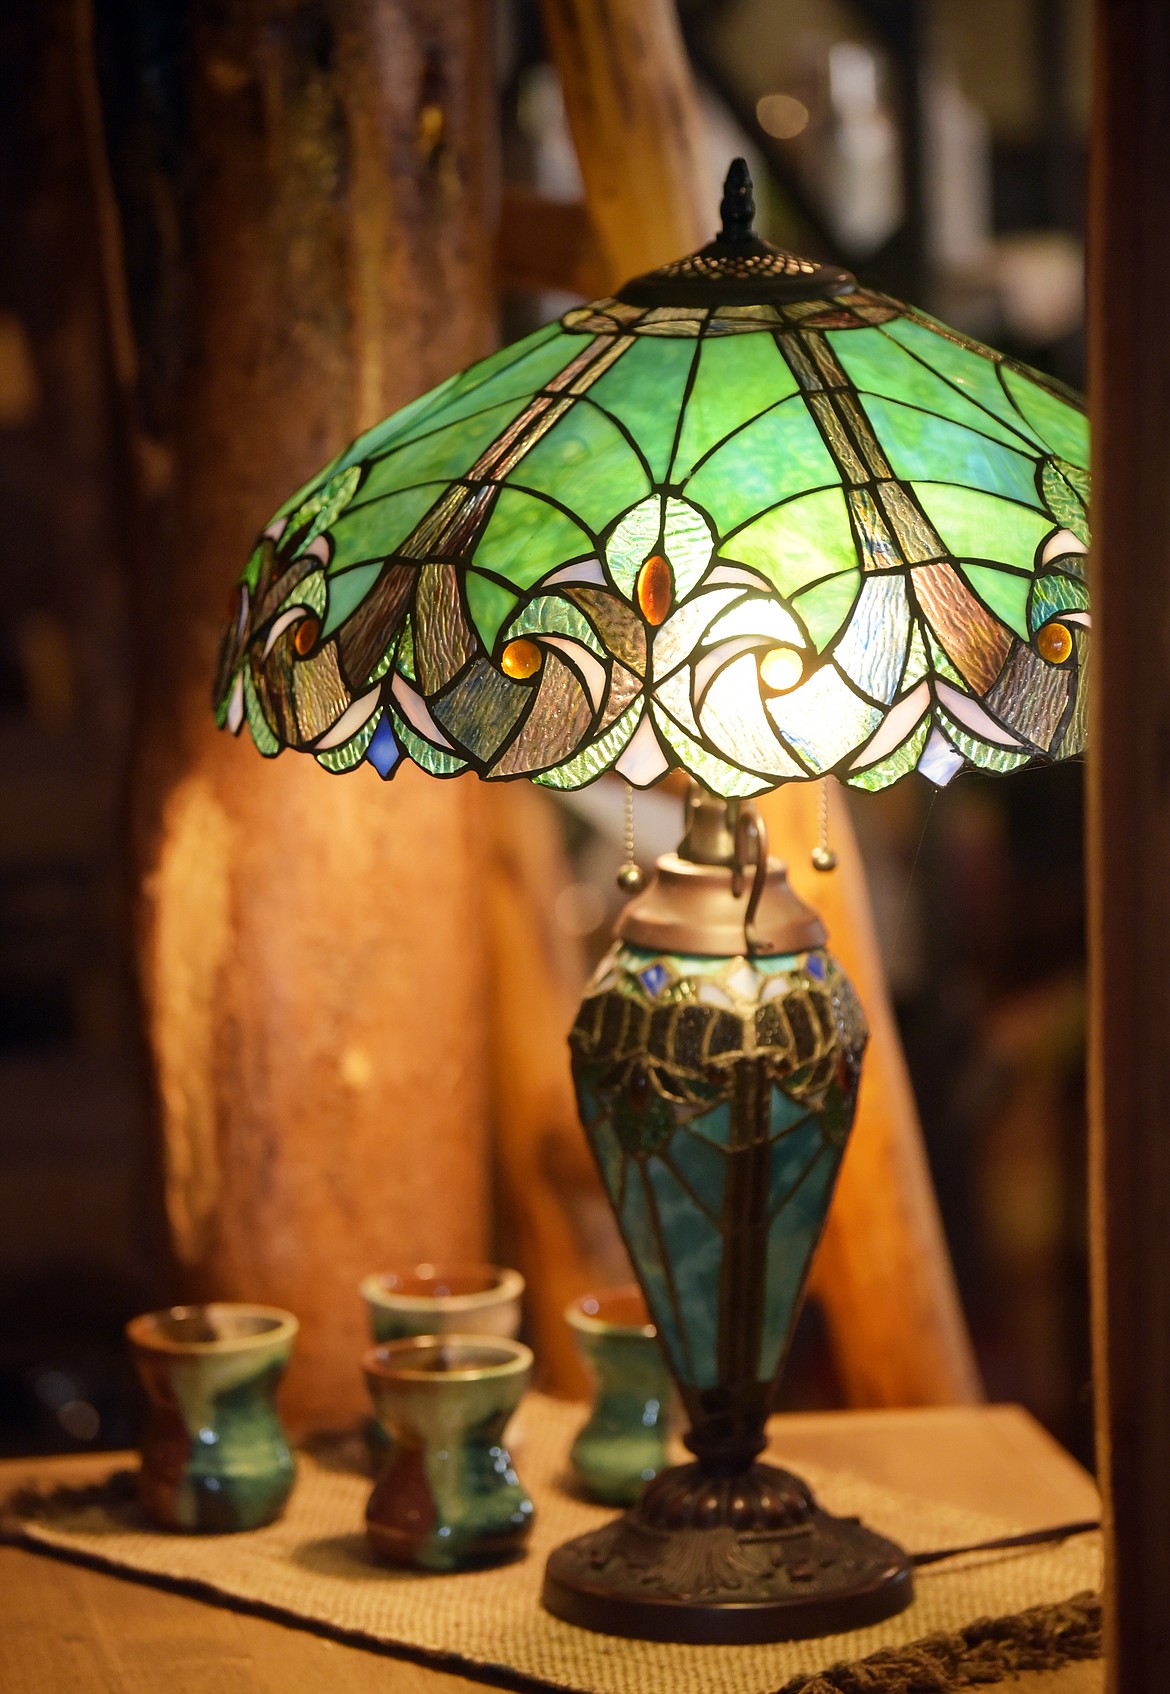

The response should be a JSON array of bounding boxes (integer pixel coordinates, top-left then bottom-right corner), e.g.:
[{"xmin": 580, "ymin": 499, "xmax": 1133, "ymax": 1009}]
[{"xmin": 0, "ymin": 1406, "xmax": 1104, "ymax": 1694}]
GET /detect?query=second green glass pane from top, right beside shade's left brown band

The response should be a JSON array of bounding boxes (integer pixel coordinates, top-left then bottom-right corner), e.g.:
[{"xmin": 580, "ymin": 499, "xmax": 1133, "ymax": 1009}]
[{"xmin": 508, "ymin": 400, "xmax": 650, "ymax": 530}]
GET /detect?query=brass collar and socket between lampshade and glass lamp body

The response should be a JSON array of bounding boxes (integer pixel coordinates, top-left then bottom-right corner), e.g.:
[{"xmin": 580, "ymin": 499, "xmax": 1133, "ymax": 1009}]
[{"xmin": 616, "ymin": 783, "xmax": 826, "ymax": 957}]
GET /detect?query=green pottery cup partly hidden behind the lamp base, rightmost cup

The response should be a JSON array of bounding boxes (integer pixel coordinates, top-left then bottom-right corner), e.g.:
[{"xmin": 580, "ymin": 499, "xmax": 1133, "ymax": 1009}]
[{"xmin": 566, "ymin": 1284, "xmax": 674, "ymax": 1506}]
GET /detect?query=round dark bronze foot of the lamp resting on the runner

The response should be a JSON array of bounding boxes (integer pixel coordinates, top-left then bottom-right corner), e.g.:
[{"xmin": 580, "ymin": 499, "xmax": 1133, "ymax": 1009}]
[{"xmin": 542, "ymin": 1464, "xmax": 914, "ymax": 1643}]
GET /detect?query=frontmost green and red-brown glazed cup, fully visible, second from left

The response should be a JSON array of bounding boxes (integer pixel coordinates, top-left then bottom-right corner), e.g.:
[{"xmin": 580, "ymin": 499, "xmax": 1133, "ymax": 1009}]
[{"xmin": 364, "ymin": 1335, "xmax": 532, "ymax": 1570}]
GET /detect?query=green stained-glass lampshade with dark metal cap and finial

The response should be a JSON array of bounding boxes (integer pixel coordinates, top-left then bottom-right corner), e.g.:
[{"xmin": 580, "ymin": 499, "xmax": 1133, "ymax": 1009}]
[{"xmin": 215, "ymin": 161, "xmax": 1089, "ymax": 796}]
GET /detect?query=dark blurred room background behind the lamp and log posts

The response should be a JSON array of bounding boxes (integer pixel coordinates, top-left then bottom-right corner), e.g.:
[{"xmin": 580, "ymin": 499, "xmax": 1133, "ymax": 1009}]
[{"xmin": 0, "ymin": 0, "xmax": 1092, "ymax": 1462}]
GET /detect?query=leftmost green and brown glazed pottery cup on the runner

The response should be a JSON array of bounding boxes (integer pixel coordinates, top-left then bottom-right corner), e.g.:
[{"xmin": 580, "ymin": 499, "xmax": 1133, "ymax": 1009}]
[{"xmin": 125, "ymin": 1303, "xmax": 296, "ymax": 1535}]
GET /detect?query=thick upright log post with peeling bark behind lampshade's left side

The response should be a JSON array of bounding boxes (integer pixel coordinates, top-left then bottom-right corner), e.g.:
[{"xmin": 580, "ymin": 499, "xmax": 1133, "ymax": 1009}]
[{"xmin": 80, "ymin": 0, "xmax": 494, "ymax": 1426}]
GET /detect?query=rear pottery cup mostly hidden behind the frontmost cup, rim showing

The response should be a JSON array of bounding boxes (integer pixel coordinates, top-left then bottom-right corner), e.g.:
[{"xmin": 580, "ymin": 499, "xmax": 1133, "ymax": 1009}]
[{"xmin": 361, "ymin": 1264, "xmax": 525, "ymax": 1342}]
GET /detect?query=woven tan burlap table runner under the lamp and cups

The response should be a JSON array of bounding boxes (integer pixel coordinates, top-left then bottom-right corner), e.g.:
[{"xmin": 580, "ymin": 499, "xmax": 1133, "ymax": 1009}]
[{"xmin": 19, "ymin": 1394, "xmax": 1101, "ymax": 1694}]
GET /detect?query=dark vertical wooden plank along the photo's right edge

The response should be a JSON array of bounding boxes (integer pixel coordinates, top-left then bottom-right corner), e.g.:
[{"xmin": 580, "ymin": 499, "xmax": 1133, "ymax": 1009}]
[{"xmin": 1089, "ymin": 0, "xmax": 1170, "ymax": 1694}]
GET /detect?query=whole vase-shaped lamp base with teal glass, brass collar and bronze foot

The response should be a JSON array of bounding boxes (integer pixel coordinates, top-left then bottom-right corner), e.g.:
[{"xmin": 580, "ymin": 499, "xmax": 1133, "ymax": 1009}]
[{"xmin": 544, "ymin": 789, "xmax": 913, "ymax": 1641}]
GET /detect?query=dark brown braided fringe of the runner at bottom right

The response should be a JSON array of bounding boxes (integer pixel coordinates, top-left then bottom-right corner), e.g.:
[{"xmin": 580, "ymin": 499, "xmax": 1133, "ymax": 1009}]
[{"xmin": 779, "ymin": 1592, "xmax": 1101, "ymax": 1694}]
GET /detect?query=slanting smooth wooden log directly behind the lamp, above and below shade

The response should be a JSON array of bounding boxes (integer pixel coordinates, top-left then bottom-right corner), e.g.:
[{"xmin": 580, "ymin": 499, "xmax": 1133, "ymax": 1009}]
[{"xmin": 542, "ymin": 0, "xmax": 980, "ymax": 1406}]
